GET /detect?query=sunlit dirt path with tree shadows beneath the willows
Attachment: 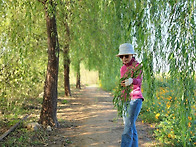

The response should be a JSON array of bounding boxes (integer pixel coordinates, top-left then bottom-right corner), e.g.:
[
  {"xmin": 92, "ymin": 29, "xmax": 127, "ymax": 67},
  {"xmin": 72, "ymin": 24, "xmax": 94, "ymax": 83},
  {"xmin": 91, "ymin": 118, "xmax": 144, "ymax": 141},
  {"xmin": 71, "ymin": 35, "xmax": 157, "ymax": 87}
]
[{"xmin": 53, "ymin": 86, "xmax": 156, "ymax": 147}]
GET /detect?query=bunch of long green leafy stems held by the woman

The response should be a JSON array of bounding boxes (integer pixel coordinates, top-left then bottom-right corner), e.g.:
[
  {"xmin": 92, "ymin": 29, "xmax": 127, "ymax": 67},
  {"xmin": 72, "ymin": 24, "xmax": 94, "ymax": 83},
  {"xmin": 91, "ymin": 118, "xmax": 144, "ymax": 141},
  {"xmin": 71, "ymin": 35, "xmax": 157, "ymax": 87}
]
[{"xmin": 113, "ymin": 62, "xmax": 142, "ymax": 117}]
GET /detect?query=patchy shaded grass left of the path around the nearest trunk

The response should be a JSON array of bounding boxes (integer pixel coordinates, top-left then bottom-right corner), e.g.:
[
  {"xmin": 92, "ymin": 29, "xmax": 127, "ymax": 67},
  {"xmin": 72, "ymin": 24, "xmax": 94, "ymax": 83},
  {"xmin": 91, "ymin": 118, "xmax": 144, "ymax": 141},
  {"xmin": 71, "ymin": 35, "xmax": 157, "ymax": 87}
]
[{"xmin": 0, "ymin": 85, "xmax": 78, "ymax": 147}]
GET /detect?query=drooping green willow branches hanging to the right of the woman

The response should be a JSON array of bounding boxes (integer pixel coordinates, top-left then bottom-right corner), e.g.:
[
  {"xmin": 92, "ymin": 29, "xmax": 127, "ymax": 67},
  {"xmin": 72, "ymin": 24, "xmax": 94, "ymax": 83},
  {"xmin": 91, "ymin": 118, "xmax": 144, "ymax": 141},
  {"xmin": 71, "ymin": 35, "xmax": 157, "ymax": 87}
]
[{"xmin": 112, "ymin": 0, "xmax": 196, "ymax": 146}]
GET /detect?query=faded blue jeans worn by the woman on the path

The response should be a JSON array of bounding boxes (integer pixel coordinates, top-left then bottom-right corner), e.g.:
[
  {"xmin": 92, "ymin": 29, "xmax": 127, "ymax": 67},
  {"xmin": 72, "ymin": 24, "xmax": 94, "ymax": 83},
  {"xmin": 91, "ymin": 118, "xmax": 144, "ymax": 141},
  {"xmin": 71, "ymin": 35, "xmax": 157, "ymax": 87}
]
[{"xmin": 121, "ymin": 99, "xmax": 142, "ymax": 147}]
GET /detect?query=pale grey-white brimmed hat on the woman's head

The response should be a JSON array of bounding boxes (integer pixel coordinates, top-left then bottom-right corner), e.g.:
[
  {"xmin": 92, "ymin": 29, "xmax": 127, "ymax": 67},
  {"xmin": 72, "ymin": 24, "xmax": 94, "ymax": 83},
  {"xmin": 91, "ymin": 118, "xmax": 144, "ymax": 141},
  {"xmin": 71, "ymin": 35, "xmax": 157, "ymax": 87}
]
[{"xmin": 116, "ymin": 43, "xmax": 136, "ymax": 57}]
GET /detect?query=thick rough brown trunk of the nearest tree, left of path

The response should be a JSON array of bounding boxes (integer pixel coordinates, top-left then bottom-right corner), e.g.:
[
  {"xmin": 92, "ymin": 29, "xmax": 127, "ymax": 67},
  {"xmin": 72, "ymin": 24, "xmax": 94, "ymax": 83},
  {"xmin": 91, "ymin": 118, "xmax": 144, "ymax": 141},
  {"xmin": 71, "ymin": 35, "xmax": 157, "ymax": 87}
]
[{"xmin": 39, "ymin": 0, "xmax": 59, "ymax": 127}]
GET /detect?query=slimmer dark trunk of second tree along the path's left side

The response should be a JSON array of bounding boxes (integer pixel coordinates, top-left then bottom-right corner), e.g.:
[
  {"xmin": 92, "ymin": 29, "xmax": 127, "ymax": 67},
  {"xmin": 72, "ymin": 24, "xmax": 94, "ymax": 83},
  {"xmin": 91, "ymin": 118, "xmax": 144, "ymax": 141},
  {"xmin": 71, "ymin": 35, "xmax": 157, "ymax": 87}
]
[{"xmin": 63, "ymin": 46, "xmax": 71, "ymax": 96}]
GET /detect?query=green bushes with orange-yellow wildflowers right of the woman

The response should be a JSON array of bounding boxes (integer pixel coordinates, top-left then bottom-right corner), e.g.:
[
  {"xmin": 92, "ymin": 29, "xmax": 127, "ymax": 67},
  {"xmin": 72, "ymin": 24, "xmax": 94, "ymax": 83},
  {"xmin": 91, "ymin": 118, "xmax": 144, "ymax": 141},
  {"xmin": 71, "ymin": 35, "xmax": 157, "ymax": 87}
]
[{"xmin": 140, "ymin": 75, "xmax": 196, "ymax": 146}]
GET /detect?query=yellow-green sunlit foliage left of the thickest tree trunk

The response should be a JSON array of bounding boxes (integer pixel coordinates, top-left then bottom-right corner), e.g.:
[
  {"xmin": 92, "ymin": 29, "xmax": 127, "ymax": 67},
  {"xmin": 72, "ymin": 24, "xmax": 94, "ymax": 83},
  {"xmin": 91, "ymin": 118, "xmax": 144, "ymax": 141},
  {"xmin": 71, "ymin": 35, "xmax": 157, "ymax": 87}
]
[{"xmin": 0, "ymin": 0, "xmax": 46, "ymax": 111}]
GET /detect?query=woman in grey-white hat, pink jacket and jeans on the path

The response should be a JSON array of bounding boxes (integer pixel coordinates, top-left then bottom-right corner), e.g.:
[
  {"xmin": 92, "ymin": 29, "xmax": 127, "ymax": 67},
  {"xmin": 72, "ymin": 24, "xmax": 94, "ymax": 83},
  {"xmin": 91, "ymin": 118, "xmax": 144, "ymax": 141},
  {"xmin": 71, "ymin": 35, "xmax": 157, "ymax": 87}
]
[{"xmin": 117, "ymin": 43, "xmax": 144, "ymax": 147}]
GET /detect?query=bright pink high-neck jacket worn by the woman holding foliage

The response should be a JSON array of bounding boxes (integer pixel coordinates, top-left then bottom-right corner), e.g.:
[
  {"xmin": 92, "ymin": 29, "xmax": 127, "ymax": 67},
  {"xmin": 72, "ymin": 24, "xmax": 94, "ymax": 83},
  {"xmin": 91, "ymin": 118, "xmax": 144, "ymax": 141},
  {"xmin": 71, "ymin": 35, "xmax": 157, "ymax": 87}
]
[{"xmin": 120, "ymin": 57, "xmax": 144, "ymax": 100}]
